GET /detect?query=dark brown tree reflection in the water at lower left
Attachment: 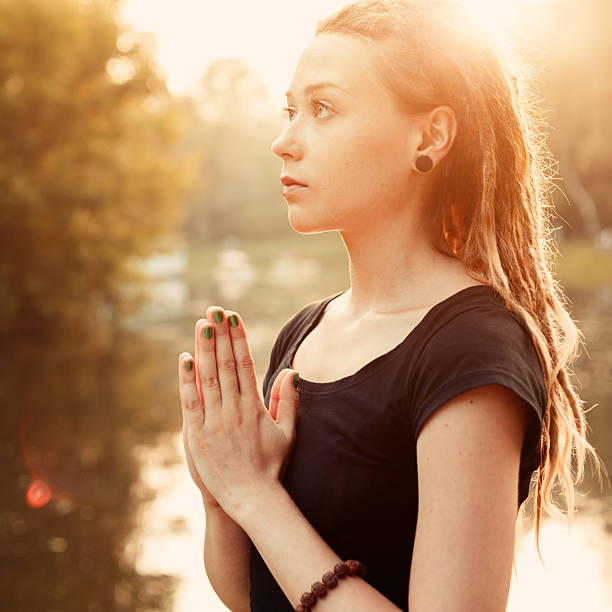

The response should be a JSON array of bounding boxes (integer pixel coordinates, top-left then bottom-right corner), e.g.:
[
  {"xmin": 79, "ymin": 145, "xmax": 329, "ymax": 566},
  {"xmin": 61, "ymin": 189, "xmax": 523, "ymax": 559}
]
[{"xmin": 0, "ymin": 332, "xmax": 180, "ymax": 612}]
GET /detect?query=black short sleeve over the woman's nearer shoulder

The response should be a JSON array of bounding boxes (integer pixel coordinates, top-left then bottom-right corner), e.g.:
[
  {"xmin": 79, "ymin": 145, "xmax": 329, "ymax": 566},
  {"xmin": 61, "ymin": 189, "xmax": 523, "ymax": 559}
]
[{"xmin": 409, "ymin": 309, "xmax": 548, "ymax": 473}]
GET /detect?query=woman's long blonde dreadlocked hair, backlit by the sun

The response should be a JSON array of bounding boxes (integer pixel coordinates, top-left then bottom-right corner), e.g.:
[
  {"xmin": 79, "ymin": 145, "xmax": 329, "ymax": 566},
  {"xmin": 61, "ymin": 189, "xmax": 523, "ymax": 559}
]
[{"xmin": 315, "ymin": 0, "xmax": 605, "ymax": 570}]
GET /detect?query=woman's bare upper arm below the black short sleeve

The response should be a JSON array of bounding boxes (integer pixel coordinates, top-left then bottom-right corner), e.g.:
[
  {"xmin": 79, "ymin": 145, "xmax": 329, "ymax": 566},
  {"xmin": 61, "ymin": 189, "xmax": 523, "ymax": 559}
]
[{"xmin": 409, "ymin": 385, "xmax": 527, "ymax": 612}]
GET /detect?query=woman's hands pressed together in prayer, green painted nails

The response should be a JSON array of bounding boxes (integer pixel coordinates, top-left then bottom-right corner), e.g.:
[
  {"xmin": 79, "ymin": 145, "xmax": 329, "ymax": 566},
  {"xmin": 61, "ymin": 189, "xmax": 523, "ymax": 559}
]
[{"xmin": 178, "ymin": 306, "xmax": 299, "ymax": 518}]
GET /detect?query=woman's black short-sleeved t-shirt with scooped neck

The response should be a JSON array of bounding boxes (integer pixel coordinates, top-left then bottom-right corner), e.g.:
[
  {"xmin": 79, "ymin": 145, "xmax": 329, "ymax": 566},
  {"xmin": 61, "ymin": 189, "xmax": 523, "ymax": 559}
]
[{"xmin": 250, "ymin": 285, "xmax": 548, "ymax": 612}]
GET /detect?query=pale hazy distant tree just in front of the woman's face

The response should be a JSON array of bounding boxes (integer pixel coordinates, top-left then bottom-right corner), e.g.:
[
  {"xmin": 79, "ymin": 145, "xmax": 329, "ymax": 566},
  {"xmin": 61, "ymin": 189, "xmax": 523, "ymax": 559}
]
[{"xmin": 185, "ymin": 58, "xmax": 291, "ymax": 244}]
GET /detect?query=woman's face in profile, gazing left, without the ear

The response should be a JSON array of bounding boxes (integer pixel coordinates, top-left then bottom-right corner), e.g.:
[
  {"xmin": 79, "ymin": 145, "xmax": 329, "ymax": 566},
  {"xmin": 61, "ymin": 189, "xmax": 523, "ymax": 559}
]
[{"xmin": 272, "ymin": 32, "xmax": 420, "ymax": 233}]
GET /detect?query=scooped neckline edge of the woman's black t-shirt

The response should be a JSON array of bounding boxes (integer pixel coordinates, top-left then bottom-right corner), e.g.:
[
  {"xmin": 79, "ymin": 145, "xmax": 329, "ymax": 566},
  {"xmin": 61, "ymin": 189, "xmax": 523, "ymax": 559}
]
[{"xmin": 283, "ymin": 285, "xmax": 495, "ymax": 393}]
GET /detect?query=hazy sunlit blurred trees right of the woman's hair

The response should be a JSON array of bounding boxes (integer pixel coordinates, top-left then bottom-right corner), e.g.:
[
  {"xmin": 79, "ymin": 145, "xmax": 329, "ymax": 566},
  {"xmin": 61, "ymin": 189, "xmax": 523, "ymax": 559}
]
[{"xmin": 521, "ymin": 0, "xmax": 612, "ymax": 241}]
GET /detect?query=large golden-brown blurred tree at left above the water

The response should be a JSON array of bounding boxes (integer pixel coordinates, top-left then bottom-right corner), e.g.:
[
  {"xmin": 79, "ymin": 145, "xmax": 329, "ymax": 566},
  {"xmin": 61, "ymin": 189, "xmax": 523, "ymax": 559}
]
[{"xmin": 0, "ymin": 0, "xmax": 194, "ymax": 333}]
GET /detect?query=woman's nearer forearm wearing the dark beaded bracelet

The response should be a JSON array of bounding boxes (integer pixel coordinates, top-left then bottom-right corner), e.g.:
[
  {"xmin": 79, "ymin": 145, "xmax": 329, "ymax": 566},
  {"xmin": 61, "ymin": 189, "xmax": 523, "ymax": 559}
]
[{"xmin": 235, "ymin": 483, "xmax": 400, "ymax": 612}]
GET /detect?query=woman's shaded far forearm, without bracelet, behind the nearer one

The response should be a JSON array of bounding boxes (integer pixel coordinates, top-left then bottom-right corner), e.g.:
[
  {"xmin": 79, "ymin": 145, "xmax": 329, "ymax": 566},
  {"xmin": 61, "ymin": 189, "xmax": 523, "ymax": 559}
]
[{"xmin": 204, "ymin": 505, "xmax": 251, "ymax": 612}]
